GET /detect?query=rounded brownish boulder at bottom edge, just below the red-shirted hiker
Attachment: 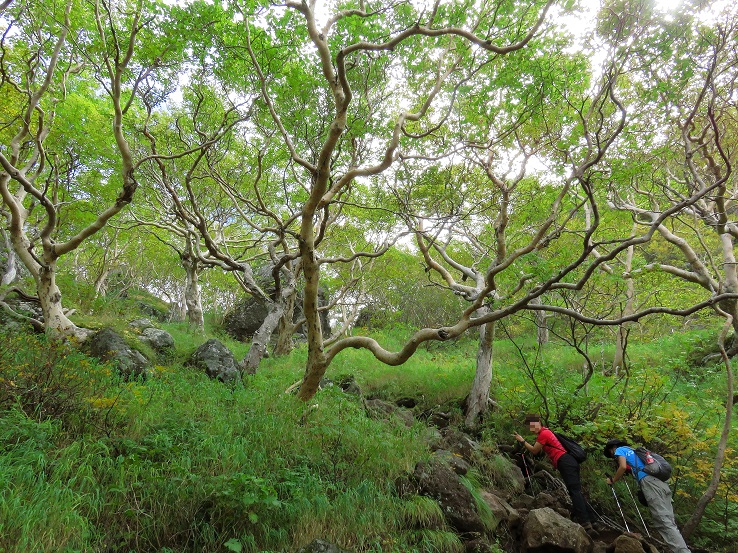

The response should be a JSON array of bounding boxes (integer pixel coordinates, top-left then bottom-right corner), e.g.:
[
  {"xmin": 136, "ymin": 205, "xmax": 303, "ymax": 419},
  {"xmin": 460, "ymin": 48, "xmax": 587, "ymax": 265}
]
[{"xmin": 522, "ymin": 507, "xmax": 594, "ymax": 553}]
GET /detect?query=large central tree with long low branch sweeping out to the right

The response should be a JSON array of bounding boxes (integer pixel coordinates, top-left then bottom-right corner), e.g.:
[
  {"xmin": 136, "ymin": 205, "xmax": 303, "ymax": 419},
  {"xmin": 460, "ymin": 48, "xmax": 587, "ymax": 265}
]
[{"xmin": 227, "ymin": 3, "xmax": 724, "ymax": 399}]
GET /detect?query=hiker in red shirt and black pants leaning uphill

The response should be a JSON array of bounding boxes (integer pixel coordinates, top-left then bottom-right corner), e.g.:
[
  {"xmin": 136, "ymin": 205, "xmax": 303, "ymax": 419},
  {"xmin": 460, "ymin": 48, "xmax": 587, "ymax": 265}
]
[{"xmin": 514, "ymin": 415, "xmax": 597, "ymax": 534}]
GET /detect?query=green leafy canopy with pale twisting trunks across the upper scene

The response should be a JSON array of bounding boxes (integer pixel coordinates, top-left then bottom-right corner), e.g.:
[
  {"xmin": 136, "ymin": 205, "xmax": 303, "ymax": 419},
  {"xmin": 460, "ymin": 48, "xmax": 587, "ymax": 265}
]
[{"xmin": 0, "ymin": 0, "xmax": 738, "ymax": 424}]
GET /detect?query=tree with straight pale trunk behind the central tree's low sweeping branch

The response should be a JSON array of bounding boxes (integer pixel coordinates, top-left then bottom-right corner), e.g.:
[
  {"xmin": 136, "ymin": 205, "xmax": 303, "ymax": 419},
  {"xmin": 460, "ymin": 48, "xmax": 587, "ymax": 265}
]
[{"xmin": 394, "ymin": 10, "xmax": 622, "ymax": 426}]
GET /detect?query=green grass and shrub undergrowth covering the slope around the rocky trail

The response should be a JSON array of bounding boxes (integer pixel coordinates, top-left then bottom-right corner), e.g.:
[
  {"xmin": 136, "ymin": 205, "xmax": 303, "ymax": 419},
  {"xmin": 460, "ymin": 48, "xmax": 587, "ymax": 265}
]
[{"xmin": 0, "ymin": 314, "xmax": 738, "ymax": 553}]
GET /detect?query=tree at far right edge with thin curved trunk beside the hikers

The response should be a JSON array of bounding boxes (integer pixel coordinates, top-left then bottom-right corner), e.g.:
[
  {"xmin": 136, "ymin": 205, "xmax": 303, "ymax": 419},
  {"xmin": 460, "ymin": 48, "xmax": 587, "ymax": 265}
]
[{"xmin": 612, "ymin": 8, "xmax": 738, "ymax": 538}]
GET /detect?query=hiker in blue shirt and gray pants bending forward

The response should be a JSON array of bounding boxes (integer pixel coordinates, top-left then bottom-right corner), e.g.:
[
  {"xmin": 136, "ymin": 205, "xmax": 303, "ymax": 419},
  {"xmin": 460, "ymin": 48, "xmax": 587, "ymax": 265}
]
[{"xmin": 603, "ymin": 439, "xmax": 690, "ymax": 553}]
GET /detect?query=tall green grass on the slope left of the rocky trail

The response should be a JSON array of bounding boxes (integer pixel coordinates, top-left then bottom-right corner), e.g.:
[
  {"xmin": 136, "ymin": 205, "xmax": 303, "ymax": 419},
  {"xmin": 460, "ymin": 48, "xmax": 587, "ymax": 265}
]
[{"xmin": 0, "ymin": 330, "xmax": 427, "ymax": 552}]
